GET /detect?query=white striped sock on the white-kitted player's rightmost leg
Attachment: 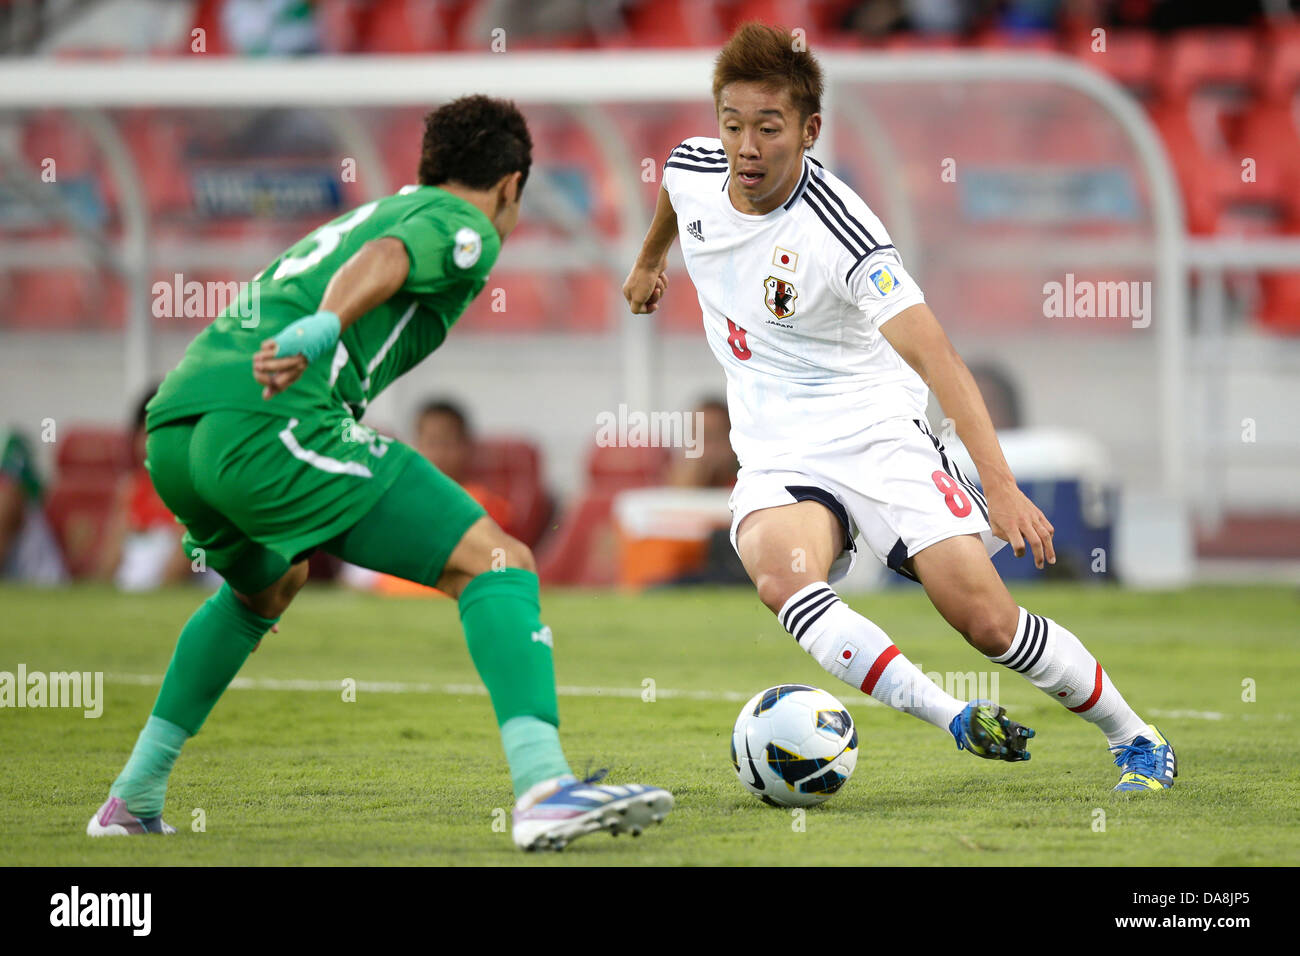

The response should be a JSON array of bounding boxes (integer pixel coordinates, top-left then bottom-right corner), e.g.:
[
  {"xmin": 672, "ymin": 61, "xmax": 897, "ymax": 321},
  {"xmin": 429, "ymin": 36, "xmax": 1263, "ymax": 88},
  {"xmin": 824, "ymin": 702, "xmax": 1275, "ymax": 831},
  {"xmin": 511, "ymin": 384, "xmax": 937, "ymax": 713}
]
[{"xmin": 989, "ymin": 607, "xmax": 1147, "ymax": 747}]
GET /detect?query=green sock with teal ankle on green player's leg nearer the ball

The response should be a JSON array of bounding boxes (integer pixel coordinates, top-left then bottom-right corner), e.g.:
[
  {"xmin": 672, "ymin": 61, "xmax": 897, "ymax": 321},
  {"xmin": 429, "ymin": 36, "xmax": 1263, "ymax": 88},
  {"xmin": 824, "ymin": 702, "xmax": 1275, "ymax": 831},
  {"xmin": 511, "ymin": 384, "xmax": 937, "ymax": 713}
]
[{"xmin": 460, "ymin": 567, "xmax": 572, "ymax": 800}]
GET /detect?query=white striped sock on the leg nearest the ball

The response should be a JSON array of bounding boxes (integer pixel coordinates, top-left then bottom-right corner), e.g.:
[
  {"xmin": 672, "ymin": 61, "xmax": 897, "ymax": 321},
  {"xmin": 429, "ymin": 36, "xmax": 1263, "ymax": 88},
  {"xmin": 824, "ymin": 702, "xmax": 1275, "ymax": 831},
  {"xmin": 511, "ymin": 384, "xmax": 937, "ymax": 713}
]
[{"xmin": 776, "ymin": 581, "xmax": 966, "ymax": 730}]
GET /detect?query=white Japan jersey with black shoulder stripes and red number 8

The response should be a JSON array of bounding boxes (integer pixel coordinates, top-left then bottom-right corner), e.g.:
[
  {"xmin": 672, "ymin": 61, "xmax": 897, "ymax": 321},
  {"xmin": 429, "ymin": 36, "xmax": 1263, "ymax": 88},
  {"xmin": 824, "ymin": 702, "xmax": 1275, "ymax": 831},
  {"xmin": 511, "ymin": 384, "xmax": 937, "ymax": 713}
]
[{"xmin": 663, "ymin": 137, "xmax": 928, "ymax": 470}]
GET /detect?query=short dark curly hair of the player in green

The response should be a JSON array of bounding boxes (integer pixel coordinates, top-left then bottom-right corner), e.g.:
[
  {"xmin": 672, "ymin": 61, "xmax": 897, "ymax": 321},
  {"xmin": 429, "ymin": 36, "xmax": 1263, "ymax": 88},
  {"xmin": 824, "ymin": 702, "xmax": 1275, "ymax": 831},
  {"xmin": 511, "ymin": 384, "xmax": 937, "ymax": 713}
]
[{"xmin": 420, "ymin": 94, "xmax": 533, "ymax": 190}]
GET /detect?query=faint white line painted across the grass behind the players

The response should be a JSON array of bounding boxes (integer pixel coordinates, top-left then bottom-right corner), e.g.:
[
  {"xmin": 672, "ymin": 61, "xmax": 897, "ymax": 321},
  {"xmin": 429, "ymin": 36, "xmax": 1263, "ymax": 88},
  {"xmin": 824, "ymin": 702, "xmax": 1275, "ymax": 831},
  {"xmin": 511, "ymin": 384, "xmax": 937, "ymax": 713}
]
[{"xmin": 104, "ymin": 674, "xmax": 1268, "ymax": 721}]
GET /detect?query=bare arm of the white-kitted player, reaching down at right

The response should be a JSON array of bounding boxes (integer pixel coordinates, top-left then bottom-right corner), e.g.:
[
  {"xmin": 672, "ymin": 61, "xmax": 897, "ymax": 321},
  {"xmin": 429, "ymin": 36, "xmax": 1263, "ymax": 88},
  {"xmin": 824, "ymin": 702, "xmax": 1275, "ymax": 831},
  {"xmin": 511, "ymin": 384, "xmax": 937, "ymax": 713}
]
[{"xmin": 880, "ymin": 303, "xmax": 1056, "ymax": 568}]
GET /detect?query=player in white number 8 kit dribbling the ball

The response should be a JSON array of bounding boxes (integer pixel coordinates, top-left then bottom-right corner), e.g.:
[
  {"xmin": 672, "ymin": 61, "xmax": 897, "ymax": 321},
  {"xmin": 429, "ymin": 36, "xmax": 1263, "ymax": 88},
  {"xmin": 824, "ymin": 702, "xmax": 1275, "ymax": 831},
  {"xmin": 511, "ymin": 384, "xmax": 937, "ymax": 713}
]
[{"xmin": 623, "ymin": 23, "xmax": 1177, "ymax": 791}]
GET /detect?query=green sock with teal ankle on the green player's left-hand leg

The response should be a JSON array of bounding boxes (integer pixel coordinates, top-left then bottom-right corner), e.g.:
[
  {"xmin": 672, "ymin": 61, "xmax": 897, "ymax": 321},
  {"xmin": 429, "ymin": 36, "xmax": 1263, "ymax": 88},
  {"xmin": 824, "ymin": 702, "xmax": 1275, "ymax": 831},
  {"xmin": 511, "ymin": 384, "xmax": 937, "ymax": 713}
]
[{"xmin": 109, "ymin": 584, "xmax": 276, "ymax": 817}]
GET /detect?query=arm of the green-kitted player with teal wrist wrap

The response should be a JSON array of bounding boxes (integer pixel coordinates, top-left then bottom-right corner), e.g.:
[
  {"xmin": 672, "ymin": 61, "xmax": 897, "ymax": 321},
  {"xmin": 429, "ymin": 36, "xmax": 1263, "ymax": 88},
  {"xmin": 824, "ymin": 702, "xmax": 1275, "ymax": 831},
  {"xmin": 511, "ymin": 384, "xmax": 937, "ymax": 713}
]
[{"xmin": 252, "ymin": 238, "xmax": 411, "ymax": 398}]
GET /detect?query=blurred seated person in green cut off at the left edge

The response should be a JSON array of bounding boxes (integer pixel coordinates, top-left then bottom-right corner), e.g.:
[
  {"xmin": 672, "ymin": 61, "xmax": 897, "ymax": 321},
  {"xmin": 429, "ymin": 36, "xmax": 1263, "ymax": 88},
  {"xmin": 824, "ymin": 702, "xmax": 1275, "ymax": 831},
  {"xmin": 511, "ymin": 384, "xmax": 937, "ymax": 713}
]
[{"xmin": 0, "ymin": 428, "xmax": 68, "ymax": 585}]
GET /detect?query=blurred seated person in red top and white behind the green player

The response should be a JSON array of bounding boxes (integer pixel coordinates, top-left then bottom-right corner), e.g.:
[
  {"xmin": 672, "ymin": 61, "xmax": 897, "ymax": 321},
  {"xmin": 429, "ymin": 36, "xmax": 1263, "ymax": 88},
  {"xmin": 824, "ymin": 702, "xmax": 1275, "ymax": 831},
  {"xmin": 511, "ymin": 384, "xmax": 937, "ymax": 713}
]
[{"xmin": 99, "ymin": 388, "xmax": 190, "ymax": 591}]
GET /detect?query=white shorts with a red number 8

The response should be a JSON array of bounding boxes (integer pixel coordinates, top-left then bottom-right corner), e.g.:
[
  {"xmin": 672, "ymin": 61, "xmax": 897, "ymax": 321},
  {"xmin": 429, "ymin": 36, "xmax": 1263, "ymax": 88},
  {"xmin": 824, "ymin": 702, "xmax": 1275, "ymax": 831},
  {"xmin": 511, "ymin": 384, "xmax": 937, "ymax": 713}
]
[{"xmin": 731, "ymin": 419, "xmax": 1006, "ymax": 581}]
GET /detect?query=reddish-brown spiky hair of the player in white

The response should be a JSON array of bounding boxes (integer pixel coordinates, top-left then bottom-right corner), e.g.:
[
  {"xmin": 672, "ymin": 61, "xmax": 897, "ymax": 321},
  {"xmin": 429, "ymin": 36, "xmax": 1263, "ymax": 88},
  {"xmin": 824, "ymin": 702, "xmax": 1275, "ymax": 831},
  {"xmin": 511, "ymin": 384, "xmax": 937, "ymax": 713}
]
[{"xmin": 714, "ymin": 22, "xmax": 823, "ymax": 120}]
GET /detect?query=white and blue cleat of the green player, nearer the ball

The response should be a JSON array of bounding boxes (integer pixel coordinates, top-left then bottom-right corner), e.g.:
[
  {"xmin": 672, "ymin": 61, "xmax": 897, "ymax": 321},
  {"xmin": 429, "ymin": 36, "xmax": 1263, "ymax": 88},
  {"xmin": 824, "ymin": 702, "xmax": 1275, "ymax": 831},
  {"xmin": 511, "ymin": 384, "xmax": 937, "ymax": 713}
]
[{"xmin": 512, "ymin": 771, "xmax": 672, "ymax": 849}]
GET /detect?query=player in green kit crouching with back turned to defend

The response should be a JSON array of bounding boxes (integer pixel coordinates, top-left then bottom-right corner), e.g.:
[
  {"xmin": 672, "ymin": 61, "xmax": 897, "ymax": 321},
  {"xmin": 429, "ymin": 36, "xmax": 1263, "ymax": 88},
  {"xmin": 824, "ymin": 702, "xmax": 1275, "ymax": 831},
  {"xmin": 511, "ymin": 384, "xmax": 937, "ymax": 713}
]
[{"xmin": 87, "ymin": 96, "xmax": 672, "ymax": 849}]
